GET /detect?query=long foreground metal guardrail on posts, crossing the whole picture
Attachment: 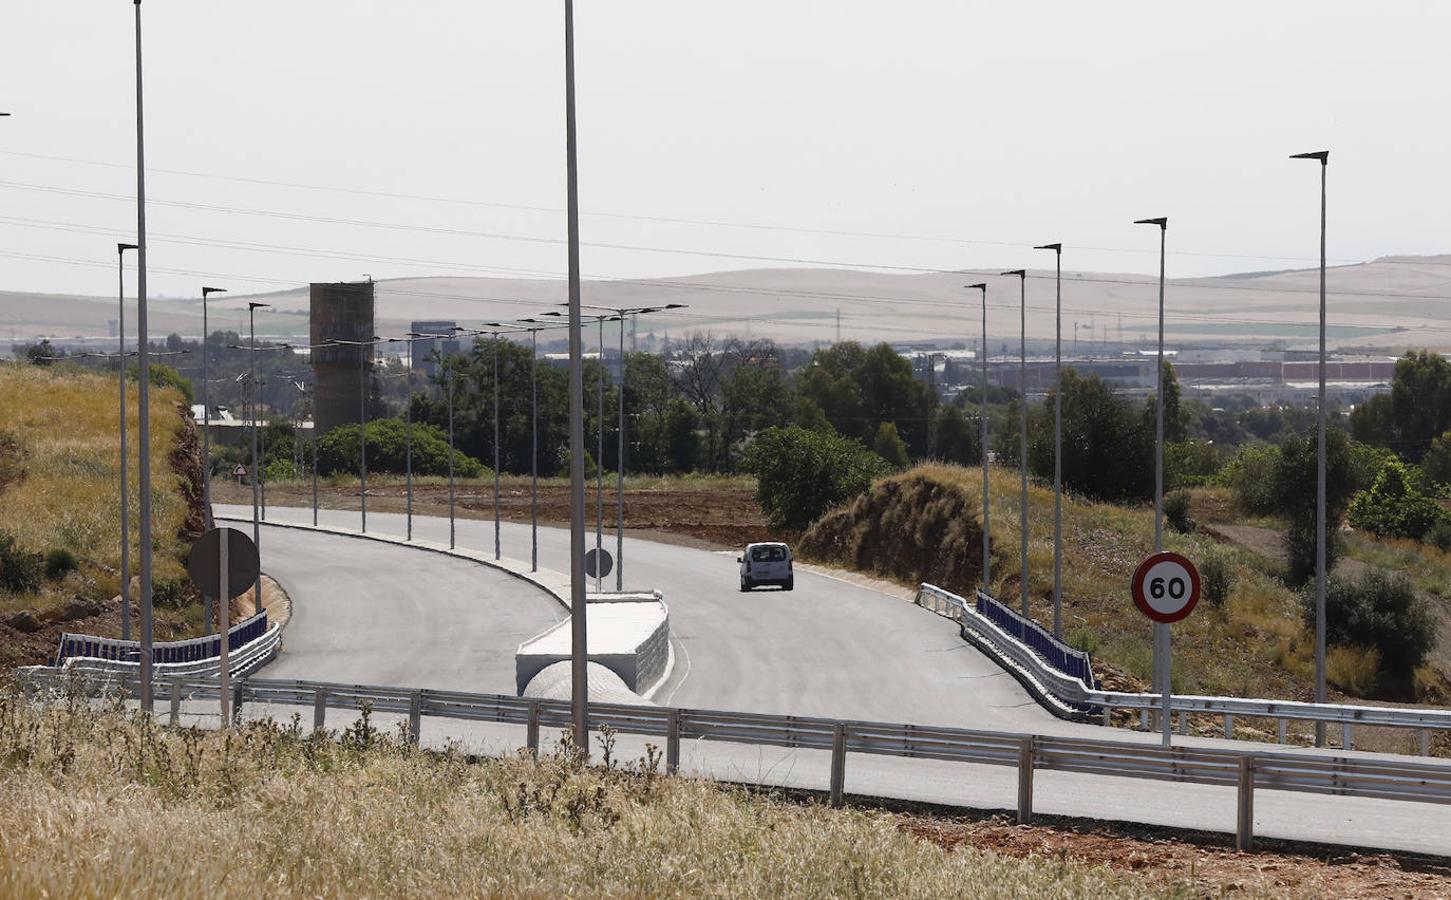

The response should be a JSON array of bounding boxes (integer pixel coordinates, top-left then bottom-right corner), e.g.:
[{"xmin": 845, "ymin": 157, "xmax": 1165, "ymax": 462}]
[{"xmin": 22, "ymin": 668, "xmax": 1451, "ymax": 849}]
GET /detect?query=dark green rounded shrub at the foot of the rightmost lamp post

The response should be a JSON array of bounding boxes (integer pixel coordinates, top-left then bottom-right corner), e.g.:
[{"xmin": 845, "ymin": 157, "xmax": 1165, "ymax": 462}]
[{"xmin": 1300, "ymin": 569, "xmax": 1436, "ymax": 682}]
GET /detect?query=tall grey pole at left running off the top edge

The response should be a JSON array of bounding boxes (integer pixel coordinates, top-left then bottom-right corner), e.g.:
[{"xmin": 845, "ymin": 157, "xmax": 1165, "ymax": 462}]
[{"xmin": 135, "ymin": 0, "xmax": 152, "ymax": 716}]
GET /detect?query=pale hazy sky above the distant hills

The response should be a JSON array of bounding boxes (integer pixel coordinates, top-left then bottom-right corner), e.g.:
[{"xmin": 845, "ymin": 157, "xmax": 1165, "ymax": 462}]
[{"xmin": 0, "ymin": 0, "xmax": 1451, "ymax": 302}]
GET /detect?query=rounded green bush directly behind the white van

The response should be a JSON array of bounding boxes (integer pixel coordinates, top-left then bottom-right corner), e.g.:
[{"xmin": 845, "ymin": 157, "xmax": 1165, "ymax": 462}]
[{"xmin": 743, "ymin": 425, "xmax": 891, "ymax": 530}]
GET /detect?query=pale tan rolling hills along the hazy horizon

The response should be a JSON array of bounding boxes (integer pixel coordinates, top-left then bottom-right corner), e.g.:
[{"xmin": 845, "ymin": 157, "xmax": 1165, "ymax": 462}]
[{"xmin": 11, "ymin": 255, "xmax": 1451, "ymax": 348}]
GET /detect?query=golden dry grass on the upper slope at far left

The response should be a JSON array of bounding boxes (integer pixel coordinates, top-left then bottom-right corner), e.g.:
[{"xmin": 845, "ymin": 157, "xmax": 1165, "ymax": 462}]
[{"xmin": 0, "ymin": 366, "xmax": 190, "ymax": 608}]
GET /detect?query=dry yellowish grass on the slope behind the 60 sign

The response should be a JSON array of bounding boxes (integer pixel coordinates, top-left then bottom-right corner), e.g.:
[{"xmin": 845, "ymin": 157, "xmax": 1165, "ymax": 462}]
[{"xmin": 807, "ymin": 465, "xmax": 1313, "ymax": 698}]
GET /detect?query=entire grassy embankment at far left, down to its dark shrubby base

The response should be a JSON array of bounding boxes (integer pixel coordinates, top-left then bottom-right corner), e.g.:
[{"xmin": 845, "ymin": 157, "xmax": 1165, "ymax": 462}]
[{"xmin": 0, "ymin": 364, "xmax": 202, "ymax": 668}]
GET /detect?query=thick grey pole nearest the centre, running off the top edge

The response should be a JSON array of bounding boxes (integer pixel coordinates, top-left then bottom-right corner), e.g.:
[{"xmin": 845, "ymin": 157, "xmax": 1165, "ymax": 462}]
[{"xmin": 564, "ymin": 0, "xmax": 589, "ymax": 759}]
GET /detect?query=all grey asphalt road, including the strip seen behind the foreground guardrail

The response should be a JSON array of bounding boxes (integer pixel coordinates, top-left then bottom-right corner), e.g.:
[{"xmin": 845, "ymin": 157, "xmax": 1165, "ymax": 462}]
[{"xmin": 211, "ymin": 508, "xmax": 1451, "ymax": 856}]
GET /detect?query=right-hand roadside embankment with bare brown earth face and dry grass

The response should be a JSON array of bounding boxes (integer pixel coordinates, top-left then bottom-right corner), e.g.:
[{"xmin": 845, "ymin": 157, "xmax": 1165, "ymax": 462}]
[{"xmin": 802, "ymin": 466, "xmax": 1451, "ymax": 743}]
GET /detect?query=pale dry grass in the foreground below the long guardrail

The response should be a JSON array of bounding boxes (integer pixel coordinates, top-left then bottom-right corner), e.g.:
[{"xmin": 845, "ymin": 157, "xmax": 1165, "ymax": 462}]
[{"xmin": 0, "ymin": 695, "xmax": 1187, "ymax": 897}]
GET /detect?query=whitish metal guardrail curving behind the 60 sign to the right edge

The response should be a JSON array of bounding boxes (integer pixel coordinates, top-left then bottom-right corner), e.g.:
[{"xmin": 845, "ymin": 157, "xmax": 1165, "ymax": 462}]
[{"xmin": 917, "ymin": 584, "xmax": 1451, "ymax": 756}]
